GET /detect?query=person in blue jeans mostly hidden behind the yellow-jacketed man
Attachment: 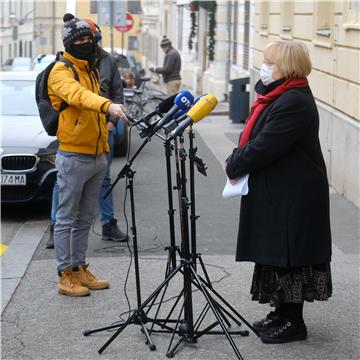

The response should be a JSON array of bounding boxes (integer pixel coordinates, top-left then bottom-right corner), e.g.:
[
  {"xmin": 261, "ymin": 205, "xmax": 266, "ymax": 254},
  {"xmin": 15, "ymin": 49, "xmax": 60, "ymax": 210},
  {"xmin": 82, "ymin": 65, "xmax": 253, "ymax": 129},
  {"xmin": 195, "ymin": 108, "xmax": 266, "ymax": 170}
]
[{"xmin": 46, "ymin": 19, "xmax": 128, "ymax": 249}]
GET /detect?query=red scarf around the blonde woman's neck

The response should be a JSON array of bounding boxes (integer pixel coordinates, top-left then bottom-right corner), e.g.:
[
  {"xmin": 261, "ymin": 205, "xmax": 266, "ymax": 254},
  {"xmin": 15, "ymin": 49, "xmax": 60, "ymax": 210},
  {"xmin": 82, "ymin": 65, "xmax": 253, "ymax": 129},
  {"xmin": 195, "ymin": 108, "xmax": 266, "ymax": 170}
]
[{"xmin": 239, "ymin": 78, "xmax": 308, "ymax": 148}]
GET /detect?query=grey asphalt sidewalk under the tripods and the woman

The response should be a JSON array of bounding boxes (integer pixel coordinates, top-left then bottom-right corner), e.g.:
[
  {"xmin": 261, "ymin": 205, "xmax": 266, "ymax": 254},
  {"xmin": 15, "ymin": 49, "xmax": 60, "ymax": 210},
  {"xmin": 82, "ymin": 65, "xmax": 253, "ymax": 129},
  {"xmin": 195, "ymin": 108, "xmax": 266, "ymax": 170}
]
[{"xmin": 1, "ymin": 116, "xmax": 359, "ymax": 360}]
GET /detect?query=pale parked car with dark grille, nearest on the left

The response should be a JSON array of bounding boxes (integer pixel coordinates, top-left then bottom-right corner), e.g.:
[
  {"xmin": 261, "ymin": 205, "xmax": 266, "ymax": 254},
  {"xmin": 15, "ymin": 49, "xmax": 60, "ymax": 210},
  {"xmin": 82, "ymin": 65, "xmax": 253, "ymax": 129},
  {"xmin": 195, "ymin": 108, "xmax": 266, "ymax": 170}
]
[{"xmin": 0, "ymin": 71, "xmax": 58, "ymax": 203}]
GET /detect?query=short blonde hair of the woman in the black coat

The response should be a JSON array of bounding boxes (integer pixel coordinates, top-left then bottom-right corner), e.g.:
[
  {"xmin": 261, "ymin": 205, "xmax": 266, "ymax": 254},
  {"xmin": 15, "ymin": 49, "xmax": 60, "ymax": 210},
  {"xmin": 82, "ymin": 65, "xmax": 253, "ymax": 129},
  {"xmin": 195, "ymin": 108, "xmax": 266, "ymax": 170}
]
[{"xmin": 264, "ymin": 40, "xmax": 311, "ymax": 78}]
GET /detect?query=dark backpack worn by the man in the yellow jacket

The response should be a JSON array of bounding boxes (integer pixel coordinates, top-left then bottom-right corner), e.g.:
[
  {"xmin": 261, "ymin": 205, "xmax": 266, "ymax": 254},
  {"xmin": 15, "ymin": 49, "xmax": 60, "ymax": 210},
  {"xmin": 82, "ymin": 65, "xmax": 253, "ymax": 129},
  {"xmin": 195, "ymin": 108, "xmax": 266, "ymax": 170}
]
[{"xmin": 35, "ymin": 52, "xmax": 79, "ymax": 136}]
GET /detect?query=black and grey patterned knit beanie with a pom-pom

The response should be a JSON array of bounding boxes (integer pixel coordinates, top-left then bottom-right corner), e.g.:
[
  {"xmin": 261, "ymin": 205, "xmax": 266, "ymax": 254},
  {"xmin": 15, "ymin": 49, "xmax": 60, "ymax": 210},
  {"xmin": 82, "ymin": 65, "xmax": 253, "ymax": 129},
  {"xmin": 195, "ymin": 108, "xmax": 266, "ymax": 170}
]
[{"xmin": 61, "ymin": 13, "xmax": 93, "ymax": 50}]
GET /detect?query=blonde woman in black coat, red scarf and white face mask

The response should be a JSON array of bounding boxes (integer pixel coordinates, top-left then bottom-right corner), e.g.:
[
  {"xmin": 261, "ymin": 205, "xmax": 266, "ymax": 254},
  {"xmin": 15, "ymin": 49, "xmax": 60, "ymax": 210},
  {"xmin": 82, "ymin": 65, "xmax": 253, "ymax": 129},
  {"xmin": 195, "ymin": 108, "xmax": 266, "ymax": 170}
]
[{"xmin": 226, "ymin": 41, "xmax": 332, "ymax": 343}]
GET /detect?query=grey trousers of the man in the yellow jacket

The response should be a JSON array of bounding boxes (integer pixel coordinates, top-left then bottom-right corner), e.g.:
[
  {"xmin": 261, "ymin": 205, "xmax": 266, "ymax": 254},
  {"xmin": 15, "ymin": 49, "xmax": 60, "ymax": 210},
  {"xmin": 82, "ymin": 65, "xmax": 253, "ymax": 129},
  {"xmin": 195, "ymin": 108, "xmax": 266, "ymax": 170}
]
[{"xmin": 54, "ymin": 153, "xmax": 107, "ymax": 271}]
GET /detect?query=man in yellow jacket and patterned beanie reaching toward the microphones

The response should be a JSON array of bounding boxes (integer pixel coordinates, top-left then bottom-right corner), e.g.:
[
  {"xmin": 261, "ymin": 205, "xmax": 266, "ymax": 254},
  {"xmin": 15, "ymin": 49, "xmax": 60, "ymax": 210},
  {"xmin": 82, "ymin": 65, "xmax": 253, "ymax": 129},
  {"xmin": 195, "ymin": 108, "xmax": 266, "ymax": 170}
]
[{"xmin": 48, "ymin": 14, "xmax": 126, "ymax": 296}]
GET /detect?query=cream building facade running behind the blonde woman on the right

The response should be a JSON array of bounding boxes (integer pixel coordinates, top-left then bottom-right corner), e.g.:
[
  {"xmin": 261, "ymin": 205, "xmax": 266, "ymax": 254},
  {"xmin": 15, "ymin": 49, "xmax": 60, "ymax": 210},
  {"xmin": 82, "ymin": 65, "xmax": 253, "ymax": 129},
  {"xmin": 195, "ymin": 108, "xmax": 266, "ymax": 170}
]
[{"xmin": 142, "ymin": 0, "xmax": 360, "ymax": 207}]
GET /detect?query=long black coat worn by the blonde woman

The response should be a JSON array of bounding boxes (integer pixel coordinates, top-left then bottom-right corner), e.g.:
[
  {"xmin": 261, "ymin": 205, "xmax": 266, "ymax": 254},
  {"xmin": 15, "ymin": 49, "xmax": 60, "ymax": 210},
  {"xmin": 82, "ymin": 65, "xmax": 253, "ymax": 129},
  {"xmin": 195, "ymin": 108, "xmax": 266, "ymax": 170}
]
[{"xmin": 226, "ymin": 80, "xmax": 331, "ymax": 267}]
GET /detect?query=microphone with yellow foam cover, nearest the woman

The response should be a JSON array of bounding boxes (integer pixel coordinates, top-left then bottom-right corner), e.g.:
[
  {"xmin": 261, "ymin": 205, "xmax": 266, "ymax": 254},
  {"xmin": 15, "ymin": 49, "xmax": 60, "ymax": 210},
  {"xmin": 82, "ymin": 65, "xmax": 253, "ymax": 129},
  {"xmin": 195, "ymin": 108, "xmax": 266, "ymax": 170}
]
[{"xmin": 170, "ymin": 94, "xmax": 218, "ymax": 139}]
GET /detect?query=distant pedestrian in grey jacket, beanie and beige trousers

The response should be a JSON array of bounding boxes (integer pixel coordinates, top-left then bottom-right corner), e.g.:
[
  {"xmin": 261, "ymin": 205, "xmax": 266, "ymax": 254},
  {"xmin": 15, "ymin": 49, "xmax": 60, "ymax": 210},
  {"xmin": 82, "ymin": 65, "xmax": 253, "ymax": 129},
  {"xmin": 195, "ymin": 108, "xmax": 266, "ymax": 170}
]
[{"xmin": 149, "ymin": 35, "xmax": 181, "ymax": 96}]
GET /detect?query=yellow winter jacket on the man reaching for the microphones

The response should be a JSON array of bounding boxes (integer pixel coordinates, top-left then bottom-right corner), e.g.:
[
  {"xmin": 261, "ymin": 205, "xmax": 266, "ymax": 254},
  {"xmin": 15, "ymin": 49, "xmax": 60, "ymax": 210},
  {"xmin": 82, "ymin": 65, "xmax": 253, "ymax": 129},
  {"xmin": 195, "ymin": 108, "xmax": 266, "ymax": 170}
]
[{"xmin": 48, "ymin": 52, "xmax": 111, "ymax": 155}]
